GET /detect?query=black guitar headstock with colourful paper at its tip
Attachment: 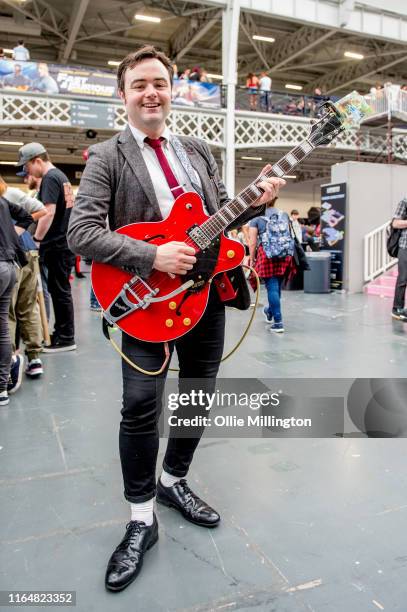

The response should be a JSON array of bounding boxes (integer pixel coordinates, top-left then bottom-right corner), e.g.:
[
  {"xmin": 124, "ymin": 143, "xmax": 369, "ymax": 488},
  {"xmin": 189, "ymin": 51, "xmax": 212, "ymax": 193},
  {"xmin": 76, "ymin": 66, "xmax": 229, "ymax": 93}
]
[{"xmin": 308, "ymin": 91, "xmax": 372, "ymax": 146}]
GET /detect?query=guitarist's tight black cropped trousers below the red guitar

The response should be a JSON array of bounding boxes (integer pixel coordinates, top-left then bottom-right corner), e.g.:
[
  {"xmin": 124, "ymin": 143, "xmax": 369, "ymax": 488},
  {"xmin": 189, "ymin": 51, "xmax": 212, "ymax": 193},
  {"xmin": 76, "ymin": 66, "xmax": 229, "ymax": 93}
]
[{"xmin": 119, "ymin": 288, "xmax": 225, "ymax": 503}]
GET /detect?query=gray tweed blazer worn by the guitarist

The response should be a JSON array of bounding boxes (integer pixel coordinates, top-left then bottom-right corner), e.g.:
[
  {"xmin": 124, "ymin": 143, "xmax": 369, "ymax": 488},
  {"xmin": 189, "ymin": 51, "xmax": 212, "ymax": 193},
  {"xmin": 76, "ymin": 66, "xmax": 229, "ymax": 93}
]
[{"xmin": 67, "ymin": 126, "xmax": 264, "ymax": 276}]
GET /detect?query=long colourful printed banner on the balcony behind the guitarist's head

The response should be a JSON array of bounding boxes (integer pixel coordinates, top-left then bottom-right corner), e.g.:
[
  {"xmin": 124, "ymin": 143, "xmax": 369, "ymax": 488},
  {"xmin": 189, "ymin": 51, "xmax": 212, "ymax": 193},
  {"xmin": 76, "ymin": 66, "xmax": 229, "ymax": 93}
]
[{"xmin": 0, "ymin": 59, "xmax": 221, "ymax": 108}]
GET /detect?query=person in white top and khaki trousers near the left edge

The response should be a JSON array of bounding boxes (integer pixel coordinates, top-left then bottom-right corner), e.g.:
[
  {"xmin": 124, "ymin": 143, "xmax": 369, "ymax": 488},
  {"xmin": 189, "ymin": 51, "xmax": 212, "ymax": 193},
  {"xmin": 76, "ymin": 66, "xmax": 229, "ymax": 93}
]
[{"xmin": 0, "ymin": 177, "xmax": 47, "ymax": 382}]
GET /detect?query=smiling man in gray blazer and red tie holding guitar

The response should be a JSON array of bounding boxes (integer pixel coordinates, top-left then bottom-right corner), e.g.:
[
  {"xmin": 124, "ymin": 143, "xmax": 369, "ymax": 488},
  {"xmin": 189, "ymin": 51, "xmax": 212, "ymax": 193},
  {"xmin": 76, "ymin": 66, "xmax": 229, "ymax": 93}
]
[{"xmin": 69, "ymin": 47, "xmax": 285, "ymax": 591}]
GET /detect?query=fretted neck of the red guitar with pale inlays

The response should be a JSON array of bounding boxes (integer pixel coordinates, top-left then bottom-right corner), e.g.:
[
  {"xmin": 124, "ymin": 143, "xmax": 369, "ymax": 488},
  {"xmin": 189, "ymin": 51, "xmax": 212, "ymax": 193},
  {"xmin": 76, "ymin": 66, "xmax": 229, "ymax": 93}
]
[{"xmin": 200, "ymin": 140, "xmax": 315, "ymax": 240}]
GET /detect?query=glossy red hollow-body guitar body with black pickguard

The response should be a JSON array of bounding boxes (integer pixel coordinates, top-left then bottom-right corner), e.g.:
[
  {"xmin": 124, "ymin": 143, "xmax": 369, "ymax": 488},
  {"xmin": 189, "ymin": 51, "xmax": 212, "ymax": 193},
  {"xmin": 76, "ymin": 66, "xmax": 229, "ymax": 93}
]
[{"xmin": 91, "ymin": 192, "xmax": 244, "ymax": 342}]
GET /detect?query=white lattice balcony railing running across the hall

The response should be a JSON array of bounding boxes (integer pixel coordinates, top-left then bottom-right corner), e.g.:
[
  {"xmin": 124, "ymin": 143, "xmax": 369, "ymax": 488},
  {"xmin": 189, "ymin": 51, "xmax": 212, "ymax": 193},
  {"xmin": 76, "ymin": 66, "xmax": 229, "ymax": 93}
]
[{"xmin": 0, "ymin": 91, "xmax": 407, "ymax": 160}]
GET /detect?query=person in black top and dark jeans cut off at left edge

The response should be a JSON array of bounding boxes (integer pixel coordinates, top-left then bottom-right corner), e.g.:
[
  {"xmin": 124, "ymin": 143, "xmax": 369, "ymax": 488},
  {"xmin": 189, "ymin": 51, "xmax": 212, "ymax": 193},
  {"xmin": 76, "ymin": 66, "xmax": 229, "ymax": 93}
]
[{"xmin": 0, "ymin": 197, "xmax": 34, "ymax": 406}]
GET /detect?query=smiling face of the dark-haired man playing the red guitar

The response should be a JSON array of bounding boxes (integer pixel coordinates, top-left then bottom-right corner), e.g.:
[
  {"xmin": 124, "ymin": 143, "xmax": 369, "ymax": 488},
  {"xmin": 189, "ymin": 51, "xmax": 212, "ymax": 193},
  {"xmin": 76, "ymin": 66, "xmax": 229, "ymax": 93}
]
[{"xmin": 119, "ymin": 58, "xmax": 171, "ymax": 134}]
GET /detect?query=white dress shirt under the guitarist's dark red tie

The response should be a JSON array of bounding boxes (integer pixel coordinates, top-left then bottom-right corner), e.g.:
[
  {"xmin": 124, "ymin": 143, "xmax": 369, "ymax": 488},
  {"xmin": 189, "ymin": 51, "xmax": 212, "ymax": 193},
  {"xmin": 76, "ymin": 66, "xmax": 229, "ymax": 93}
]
[{"xmin": 129, "ymin": 124, "xmax": 202, "ymax": 219}]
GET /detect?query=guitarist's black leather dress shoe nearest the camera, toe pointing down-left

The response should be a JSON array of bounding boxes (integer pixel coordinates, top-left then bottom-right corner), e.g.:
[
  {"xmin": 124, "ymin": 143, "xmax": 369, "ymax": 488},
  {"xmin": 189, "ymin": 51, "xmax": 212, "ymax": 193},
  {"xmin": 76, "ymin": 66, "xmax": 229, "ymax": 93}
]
[{"xmin": 105, "ymin": 515, "xmax": 158, "ymax": 591}]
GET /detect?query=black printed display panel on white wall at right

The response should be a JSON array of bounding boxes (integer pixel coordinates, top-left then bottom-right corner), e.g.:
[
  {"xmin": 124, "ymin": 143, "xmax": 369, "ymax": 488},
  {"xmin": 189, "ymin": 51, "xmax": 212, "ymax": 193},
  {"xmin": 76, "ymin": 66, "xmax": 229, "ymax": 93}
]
[{"xmin": 321, "ymin": 183, "xmax": 346, "ymax": 289}]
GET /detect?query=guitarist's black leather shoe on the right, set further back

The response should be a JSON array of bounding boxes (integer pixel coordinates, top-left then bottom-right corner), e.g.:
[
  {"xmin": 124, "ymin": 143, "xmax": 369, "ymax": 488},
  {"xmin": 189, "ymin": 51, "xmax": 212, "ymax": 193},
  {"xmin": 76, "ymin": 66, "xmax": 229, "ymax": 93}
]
[{"xmin": 156, "ymin": 478, "xmax": 220, "ymax": 527}]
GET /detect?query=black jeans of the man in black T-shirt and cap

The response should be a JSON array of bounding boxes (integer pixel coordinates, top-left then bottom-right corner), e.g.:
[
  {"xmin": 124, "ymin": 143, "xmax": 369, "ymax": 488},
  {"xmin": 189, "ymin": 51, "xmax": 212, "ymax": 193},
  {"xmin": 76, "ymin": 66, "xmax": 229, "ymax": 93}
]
[{"xmin": 41, "ymin": 248, "xmax": 75, "ymax": 342}]
